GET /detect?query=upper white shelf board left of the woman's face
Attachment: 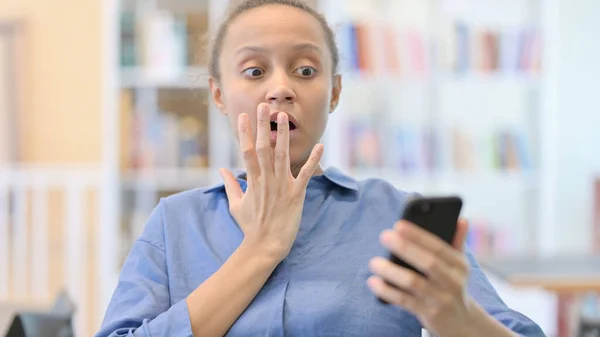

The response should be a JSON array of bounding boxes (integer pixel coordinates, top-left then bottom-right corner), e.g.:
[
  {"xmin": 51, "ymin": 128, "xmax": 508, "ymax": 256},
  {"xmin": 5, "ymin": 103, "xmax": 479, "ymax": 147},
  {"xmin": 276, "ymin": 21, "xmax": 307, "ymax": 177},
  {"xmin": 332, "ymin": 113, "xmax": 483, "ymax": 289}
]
[{"xmin": 121, "ymin": 67, "xmax": 208, "ymax": 89}]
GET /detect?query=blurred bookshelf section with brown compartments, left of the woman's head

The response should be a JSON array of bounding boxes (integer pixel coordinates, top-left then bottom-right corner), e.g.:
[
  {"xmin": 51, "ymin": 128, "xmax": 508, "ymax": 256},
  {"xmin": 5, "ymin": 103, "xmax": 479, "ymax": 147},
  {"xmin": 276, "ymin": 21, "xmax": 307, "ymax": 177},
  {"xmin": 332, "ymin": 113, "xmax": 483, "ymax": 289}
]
[{"xmin": 117, "ymin": 0, "xmax": 219, "ymax": 259}]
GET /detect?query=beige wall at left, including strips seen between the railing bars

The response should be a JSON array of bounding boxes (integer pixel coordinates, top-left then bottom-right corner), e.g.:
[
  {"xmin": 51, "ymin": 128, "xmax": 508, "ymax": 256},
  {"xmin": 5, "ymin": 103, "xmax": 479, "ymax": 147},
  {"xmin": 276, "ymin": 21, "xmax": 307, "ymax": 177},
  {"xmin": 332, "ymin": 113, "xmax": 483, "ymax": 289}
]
[{"xmin": 0, "ymin": 0, "xmax": 105, "ymax": 335}]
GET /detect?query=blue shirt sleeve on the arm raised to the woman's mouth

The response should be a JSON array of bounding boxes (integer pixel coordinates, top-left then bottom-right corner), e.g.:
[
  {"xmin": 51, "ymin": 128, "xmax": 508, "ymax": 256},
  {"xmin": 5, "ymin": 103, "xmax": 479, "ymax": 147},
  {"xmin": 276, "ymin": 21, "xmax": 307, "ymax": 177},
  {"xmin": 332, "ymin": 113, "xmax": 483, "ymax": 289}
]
[{"xmin": 96, "ymin": 203, "xmax": 192, "ymax": 337}]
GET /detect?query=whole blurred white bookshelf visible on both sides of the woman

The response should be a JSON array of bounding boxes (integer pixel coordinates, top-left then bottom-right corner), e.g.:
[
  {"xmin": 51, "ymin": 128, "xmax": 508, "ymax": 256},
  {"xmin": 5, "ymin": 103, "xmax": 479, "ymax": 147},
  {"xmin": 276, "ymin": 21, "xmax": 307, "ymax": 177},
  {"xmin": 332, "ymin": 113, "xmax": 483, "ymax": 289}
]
[{"xmin": 111, "ymin": 0, "xmax": 543, "ymax": 255}]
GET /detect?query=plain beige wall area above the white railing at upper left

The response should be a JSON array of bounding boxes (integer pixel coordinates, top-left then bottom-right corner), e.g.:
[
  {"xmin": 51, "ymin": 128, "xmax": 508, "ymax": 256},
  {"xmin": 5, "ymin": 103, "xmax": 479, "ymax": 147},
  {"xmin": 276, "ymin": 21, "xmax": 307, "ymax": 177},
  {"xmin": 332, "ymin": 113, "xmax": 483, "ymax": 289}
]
[{"xmin": 0, "ymin": 0, "xmax": 102, "ymax": 163}]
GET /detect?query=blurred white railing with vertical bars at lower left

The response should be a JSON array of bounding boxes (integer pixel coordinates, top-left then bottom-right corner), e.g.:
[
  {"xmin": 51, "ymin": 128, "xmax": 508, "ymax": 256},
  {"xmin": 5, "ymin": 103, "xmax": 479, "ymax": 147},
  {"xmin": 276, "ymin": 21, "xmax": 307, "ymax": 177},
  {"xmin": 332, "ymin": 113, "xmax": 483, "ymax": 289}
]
[{"xmin": 0, "ymin": 167, "xmax": 106, "ymax": 336}]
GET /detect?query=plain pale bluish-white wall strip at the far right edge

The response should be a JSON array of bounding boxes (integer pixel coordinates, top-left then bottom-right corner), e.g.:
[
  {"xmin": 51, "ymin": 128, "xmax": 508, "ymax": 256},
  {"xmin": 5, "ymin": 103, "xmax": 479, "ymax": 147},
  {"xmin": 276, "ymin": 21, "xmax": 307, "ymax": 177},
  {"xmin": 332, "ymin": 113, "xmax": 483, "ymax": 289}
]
[{"xmin": 554, "ymin": 0, "xmax": 600, "ymax": 252}]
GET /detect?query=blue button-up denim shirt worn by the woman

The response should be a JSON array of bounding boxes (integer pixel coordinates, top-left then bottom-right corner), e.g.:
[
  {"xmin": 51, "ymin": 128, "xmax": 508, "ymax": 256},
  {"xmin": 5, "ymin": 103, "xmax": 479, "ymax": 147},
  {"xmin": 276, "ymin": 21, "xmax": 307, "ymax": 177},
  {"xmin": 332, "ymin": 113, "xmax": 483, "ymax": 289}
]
[{"xmin": 96, "ymin": 168, "xmax": 544, "ymax": 337}]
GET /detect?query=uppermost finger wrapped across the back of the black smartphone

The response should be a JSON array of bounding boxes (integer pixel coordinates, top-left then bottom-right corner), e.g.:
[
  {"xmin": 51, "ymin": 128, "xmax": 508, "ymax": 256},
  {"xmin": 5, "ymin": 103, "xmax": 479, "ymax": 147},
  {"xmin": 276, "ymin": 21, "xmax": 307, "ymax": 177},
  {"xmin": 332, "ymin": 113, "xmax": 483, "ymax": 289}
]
[{"xmin": 395, "ymin": 220, "xmax": 463, "ymax": 267}]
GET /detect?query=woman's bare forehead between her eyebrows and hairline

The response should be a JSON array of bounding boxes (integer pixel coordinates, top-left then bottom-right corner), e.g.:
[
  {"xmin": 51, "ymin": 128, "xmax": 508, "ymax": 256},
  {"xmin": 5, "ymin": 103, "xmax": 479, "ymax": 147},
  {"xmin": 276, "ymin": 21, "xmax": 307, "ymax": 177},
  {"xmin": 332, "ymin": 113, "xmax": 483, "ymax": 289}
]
[{"xmin": 223, "ymin": 5, "xmax": 327, "ymax": 52}]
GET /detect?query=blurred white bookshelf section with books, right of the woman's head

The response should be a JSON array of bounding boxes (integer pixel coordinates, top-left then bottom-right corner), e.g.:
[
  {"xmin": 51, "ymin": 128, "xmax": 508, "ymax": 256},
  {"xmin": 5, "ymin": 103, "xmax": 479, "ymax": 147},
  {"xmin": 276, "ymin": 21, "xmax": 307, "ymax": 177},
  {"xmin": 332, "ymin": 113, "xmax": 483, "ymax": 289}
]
[{"xmin": 319, "ymin": 0, "xmax": 543, "ymax": 256}]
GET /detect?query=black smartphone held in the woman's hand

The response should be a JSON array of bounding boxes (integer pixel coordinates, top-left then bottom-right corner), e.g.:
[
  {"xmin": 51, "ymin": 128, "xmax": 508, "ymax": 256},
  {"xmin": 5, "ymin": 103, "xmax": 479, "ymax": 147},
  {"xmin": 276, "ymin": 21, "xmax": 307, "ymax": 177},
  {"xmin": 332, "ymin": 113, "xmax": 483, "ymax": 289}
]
[{"xmin": 379, "ymin": 196, "xmax": 463, "ymax": 303}]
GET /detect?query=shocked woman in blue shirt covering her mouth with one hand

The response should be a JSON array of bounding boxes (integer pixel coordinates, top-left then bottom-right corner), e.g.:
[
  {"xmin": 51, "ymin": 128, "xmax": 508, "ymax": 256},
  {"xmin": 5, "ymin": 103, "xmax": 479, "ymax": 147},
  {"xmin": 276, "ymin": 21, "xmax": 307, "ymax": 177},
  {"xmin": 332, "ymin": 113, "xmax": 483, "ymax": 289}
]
[{"xmin": 97, "ymin": 0, "xmax": 543, "ymax": 337}]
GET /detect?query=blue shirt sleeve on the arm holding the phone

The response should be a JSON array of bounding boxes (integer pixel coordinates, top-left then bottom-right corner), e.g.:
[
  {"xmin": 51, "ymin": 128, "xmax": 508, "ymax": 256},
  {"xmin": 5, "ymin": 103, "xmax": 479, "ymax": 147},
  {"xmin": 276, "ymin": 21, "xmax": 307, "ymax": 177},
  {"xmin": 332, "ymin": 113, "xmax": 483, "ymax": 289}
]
[{"xmin": 466, "ymin": 249, "xmax": 546, "ymax": 337}]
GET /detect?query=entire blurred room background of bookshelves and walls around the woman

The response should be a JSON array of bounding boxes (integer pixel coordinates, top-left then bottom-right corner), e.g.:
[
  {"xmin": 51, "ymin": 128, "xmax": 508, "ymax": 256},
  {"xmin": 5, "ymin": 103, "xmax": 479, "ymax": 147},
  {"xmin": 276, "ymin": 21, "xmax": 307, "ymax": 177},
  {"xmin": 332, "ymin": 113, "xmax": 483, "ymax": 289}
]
[{"xmin": 0, "ymin": 0, "xmax": 600, "ymax": 336}]
